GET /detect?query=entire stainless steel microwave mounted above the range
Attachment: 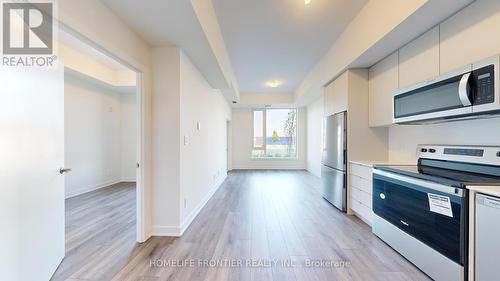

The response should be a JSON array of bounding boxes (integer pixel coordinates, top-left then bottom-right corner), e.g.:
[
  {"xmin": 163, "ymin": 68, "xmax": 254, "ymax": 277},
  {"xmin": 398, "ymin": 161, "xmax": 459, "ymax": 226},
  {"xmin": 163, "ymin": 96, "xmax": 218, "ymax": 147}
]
[{"xmin": 393, "ymin": 55, "xmax": 500, "ymax": 124}]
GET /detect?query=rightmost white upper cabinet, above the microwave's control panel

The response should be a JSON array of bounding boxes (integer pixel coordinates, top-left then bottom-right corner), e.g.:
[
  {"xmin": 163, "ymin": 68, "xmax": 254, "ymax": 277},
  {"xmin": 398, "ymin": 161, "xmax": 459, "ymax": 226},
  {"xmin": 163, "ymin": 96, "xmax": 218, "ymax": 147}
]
[{"xmin": 440, "ymin": 0, "xmax": 500, "ymax": 73}]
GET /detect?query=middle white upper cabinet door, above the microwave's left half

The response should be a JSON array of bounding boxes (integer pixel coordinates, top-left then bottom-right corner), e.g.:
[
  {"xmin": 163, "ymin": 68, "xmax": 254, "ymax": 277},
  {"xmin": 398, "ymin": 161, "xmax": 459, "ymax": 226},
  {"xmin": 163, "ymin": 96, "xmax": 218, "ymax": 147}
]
[{"xmin": 399, "ymin": 26, "xmax": 439, "ymax": 89}]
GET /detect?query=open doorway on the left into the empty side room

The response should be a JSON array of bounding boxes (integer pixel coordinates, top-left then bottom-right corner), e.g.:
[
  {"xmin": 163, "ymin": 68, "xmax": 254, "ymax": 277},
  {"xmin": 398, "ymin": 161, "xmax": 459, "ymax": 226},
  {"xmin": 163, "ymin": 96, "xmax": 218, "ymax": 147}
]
[{"xmin": 54, "ymin": 26, "xmax": 145, "ymax": 279}]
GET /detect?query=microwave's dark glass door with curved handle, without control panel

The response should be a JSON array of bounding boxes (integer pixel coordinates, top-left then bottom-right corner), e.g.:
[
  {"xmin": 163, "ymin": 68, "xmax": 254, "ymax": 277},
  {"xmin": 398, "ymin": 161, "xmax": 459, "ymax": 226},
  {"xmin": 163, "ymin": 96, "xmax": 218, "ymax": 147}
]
[{"xmin": 393, "ymin": 65, "xmax": 473, "ymax": 123}]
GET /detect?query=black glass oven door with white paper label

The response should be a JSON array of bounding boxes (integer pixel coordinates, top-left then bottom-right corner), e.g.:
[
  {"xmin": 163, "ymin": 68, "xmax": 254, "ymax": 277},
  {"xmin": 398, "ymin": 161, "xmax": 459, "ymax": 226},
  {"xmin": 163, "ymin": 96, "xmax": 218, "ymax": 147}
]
[{"xmin": 373, "ymin": 169, "xmax": 467, "ymax": 265}]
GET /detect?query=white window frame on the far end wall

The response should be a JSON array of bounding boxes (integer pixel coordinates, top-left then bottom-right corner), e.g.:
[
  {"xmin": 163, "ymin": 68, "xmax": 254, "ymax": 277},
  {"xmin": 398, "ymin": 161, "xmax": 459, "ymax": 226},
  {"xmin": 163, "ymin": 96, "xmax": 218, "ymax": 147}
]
[{"xmin": 250, "ymin": 107, "xmax": 299, "ymax": 161}]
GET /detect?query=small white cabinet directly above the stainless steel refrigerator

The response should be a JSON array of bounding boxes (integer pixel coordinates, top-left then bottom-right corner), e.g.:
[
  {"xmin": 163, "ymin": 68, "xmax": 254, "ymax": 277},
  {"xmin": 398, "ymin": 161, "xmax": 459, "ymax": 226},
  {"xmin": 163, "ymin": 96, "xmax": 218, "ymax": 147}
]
[{"xmin": 324, "ymin": 71, "xmax": 348, "ymax": 116}]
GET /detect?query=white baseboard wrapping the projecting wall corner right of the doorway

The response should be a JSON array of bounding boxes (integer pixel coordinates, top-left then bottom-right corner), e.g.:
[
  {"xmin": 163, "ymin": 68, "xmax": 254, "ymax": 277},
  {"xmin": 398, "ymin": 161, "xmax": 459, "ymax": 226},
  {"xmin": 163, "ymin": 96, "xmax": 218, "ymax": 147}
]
[{"xmin": 151, "ymin": 173, "xmax": 227, "ymax": 237}]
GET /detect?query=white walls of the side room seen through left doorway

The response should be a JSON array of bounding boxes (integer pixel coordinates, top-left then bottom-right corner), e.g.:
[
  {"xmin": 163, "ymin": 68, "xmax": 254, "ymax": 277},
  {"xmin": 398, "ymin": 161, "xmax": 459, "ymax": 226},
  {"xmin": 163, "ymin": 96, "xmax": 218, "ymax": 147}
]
[{"xmin": 64, "ymin": 74, "xmax": 136, "ymax": 197}]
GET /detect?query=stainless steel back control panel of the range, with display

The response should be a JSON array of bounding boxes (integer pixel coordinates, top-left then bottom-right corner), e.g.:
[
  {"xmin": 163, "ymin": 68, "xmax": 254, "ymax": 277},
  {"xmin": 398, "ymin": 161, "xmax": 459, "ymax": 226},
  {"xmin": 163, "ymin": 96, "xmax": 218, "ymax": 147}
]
[{"xmin": 417, "ymin": 144, "xmax": 500, "ymax": 165}]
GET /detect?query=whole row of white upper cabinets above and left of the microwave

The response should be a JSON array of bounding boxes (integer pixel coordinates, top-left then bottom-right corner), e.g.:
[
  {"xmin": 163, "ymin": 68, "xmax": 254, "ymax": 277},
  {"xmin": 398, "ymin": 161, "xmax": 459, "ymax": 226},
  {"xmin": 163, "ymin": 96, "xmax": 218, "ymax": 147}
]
[{"xmin": 369, "ymin": 0, "xmax": 500, "ymax": 127}]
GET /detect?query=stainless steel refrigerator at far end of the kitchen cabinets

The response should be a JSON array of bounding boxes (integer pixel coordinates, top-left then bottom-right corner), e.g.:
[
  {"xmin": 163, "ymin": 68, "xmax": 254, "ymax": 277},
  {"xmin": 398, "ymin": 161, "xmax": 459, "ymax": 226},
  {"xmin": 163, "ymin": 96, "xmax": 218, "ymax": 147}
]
[{"xmin": 321, "ymin": 112, "xmax": 347, "ymax": 212}]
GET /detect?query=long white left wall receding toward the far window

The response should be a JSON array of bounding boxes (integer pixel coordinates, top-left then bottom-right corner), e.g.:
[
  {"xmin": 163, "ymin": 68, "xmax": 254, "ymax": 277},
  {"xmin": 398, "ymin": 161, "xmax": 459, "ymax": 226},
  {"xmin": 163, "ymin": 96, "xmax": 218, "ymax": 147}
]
[{"xmin": 180, "ymin": 53, "xmax": 231, "ymax": 231}]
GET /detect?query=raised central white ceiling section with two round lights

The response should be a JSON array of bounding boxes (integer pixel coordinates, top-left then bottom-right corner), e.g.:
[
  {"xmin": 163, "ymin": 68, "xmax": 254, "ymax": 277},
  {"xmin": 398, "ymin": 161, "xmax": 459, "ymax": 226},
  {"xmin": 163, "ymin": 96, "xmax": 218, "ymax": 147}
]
[{"xmin": 212, "ymin": 0, "xmax": 367, "ymax": 93}]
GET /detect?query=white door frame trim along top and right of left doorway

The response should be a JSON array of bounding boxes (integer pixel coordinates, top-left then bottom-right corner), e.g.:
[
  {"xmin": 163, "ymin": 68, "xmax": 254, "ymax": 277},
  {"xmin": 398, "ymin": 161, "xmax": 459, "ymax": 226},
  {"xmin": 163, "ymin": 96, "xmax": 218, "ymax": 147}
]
[{"xmin": 58, "ymin": 21, "xmax": 148, "ymax": 243}]
